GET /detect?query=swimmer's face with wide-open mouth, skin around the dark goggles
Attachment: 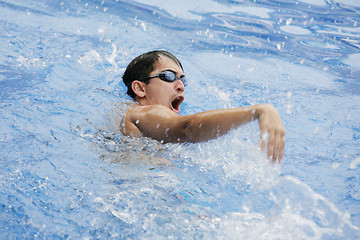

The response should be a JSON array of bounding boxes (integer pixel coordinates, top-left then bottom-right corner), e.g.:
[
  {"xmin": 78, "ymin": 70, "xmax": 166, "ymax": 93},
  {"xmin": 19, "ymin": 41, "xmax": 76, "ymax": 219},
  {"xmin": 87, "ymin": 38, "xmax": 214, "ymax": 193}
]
[{"xmin": 139, "ymin": 55, "xmax": 185, "ymax": 113}]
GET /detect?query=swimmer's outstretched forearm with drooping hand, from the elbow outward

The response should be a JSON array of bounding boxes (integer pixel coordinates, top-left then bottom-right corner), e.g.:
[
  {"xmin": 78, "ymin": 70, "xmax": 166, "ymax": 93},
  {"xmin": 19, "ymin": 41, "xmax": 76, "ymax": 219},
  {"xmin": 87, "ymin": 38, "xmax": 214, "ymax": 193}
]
[{"xmin": 187, "ymin": 104, "xmax": 285, "ymax": 162}]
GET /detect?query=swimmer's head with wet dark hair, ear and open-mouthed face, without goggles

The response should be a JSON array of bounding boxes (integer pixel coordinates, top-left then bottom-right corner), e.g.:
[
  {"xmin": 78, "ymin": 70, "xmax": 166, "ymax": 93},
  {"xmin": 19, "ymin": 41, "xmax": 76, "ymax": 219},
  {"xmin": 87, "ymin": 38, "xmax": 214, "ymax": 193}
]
[{"xmin": 123, "ymin": 50, "xmax": 184, "ymax": 112}]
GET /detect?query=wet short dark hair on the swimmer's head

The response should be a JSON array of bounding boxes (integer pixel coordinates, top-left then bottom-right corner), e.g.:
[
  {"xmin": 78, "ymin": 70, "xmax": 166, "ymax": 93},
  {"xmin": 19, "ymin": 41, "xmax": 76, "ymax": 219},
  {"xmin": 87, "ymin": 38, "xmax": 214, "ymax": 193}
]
[{"xmin": 122, "ymin": 50, "xmax": 184, "ymax": 99}]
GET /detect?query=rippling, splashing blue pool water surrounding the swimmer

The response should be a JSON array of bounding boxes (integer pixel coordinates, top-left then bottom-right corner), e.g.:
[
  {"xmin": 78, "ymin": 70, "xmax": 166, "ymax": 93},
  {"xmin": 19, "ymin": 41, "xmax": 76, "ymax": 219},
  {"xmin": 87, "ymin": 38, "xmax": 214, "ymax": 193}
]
[{"xmin": 0, "ymin": 0, "xmax": 360, "ymax": 239}]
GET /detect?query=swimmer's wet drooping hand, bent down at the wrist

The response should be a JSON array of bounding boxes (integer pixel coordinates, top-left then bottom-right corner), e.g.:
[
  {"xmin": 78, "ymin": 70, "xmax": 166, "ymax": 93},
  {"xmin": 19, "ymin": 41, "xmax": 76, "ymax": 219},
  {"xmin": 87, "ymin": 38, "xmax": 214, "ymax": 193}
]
[{"xmin": 257, "ymin": 104, "xmax": 285, "ymax": 163}]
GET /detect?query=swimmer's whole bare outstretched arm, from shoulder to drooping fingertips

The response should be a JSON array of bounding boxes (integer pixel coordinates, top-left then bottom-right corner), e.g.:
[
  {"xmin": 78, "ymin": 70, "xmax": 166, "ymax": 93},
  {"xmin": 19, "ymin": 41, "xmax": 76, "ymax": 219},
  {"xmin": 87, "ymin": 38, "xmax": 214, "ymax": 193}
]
[{"xmin": 125, "ymin": 104, "xmax": 285, "ymax": 161}]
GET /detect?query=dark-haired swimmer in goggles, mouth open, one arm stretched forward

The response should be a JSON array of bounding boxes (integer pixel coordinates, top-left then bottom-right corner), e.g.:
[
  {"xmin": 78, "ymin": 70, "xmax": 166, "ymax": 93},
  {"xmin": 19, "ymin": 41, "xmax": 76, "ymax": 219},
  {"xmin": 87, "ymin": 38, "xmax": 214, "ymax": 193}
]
[{"xmin": 121, "ymin": 50, "xmax": 285, "ymax": 163}]
